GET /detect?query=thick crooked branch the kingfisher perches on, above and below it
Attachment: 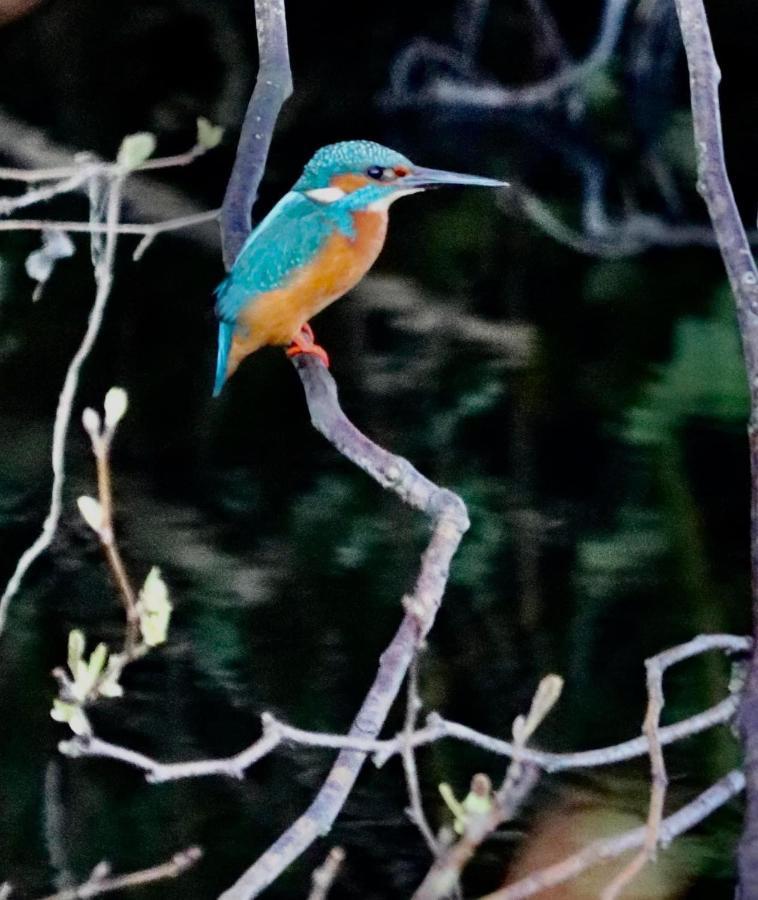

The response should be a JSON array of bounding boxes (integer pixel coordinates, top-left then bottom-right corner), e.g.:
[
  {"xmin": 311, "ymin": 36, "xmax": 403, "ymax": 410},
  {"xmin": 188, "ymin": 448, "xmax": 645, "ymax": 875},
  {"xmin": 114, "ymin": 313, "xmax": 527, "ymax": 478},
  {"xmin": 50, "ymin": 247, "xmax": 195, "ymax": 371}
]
[{"xmin": 214, "ymin": 0, "xmax": 468, "ymax": 900}]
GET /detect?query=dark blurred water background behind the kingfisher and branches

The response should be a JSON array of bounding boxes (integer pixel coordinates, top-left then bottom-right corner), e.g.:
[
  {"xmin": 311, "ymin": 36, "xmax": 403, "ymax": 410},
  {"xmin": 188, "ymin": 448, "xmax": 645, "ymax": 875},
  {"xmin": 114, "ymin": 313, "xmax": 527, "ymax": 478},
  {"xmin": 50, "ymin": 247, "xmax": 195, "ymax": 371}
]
[{"xmin": 0, "ymin": 0, "xmax": 755, "ymax": 898}]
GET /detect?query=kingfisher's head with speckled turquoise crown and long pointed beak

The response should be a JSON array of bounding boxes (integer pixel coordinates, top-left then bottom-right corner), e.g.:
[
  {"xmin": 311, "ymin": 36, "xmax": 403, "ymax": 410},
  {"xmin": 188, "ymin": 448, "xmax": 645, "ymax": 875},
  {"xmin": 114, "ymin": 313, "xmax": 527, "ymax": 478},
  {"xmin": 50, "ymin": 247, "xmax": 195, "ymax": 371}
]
[{"xmin": 293, "ymin": 141, "xmax": 507, "ymax": 209}]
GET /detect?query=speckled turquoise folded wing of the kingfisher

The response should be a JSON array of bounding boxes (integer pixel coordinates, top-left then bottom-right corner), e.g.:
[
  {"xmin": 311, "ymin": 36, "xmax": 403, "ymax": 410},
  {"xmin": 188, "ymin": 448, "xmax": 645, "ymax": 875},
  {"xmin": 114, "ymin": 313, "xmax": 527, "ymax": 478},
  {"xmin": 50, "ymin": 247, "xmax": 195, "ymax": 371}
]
[{"xmin": 216, "ymin": 192, "xmax": 336, "ymax": 323}]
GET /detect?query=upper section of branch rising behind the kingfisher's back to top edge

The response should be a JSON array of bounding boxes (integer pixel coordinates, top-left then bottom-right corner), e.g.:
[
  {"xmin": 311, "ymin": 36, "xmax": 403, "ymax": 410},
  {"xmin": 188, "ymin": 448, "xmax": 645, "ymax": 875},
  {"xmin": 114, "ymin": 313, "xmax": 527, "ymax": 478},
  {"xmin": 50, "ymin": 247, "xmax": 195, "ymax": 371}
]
[{"xmin": 220, "ymin": 0, "xmax": 292, "ymax": 272}]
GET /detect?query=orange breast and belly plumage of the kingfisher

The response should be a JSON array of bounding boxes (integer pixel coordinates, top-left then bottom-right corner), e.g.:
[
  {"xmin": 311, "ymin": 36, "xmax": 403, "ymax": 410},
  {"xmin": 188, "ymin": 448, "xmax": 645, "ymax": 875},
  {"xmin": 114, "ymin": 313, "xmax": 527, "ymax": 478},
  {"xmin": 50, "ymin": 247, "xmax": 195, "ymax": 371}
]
[{"xmin": 228, "ymin": 212, "xmax": 387, "ymax": 375}]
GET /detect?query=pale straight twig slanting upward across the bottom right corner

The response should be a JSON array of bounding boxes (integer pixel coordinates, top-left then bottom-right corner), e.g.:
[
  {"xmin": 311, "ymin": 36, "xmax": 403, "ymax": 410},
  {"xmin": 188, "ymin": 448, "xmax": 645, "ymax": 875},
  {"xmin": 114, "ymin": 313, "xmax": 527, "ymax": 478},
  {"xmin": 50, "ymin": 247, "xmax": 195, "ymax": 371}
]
[{"xmin": 479, "ymin": 769, "xmax": 745, "ymax": 900}]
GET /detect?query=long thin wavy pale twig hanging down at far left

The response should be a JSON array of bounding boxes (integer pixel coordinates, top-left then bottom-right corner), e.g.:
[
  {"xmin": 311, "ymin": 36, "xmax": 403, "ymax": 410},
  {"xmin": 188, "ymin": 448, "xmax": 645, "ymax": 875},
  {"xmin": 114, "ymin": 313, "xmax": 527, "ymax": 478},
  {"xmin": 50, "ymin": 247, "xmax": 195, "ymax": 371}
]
[{"xmin": 0, "ymin": 175, "xmax": 123, "ymax": 634}]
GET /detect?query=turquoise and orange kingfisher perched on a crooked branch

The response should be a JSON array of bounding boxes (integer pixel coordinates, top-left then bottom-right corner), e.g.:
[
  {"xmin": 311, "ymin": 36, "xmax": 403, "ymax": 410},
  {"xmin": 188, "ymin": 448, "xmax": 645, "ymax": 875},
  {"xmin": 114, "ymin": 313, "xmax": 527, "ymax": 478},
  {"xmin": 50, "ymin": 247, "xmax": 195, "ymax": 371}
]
[{"xmin": 213, "ymin": 140, "xmax": 507, "ymax": 397}]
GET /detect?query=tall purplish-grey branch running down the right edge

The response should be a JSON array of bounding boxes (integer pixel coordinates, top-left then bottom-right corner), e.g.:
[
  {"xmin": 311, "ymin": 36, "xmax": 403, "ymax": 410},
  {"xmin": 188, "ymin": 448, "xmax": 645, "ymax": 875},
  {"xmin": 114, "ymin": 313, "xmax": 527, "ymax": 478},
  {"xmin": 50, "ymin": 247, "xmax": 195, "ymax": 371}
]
[{"xmin": 676, "ymin": 0, "xmax": 758, "ymax": 900}]
